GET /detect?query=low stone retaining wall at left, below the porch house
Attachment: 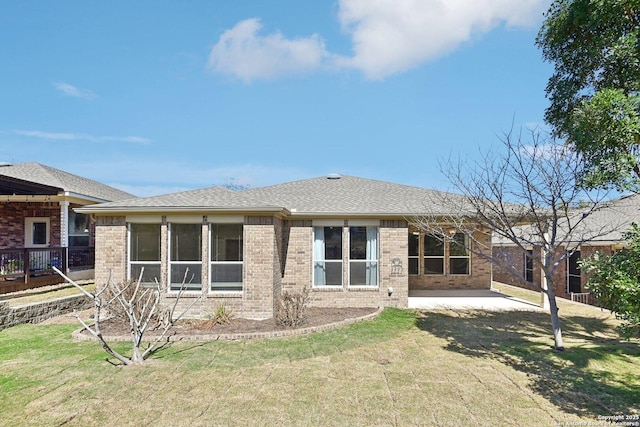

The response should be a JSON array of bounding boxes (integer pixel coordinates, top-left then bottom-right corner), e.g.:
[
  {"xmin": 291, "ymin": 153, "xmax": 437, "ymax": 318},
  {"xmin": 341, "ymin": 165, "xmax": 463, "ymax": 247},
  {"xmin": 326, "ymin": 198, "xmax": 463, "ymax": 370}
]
[{"xmin": 0, "ymin": 295, "xmax": 93, "ymax": 331}]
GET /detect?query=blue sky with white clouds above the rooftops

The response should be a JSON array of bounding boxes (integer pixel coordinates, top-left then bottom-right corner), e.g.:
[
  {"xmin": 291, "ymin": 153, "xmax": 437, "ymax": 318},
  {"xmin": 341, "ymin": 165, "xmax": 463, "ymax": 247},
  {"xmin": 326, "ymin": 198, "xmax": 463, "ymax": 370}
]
[{"xmin": 0, "ymin": 0, "xmax": 552, "ymax": 196}]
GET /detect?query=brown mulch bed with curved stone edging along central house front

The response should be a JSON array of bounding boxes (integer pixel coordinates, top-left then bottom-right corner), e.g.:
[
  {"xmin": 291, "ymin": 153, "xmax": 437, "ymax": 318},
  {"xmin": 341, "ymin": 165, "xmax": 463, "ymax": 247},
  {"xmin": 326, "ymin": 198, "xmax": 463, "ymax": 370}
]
[{"xmin": 70, "ymin": 307, "xmax": 378, "ymax": 341}]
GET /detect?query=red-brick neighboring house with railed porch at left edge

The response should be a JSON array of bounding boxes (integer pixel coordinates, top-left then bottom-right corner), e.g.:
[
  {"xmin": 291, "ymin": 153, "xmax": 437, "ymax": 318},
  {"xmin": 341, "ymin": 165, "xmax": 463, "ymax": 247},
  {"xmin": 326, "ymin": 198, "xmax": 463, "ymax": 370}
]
[{"xmin": 0, "ymin": 163, "xmax": 134, "ymax": 293}]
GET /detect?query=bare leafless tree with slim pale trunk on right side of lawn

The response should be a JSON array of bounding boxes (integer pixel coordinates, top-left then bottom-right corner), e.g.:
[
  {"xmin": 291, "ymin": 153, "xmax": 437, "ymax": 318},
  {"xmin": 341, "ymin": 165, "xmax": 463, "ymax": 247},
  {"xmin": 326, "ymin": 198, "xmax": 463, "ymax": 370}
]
[{"xmin": 412, "ymin": 131, "xmax": 621, "ymax": 350}]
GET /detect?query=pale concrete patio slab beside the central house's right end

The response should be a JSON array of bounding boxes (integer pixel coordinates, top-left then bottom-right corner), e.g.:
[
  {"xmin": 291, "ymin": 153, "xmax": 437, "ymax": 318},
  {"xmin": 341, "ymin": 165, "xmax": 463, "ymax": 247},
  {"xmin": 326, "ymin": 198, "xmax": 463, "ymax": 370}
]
[{"xmin": 409, "ymin": 289, "xmax": 541, "ymax": 311}]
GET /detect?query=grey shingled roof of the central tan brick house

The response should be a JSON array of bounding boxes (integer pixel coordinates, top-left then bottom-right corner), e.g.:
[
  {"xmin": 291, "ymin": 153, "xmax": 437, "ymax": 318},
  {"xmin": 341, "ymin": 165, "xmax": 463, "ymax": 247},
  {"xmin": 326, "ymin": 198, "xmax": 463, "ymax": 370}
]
[{"xmin": 78, "ymin": 175, "xmax": 470, "ymax": 217}]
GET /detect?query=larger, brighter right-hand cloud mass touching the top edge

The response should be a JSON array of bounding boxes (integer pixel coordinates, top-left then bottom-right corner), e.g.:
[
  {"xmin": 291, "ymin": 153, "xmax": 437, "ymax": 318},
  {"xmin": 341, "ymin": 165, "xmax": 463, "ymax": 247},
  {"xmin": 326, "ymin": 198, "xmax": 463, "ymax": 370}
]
[{"xmin": 339, "ymin": 0, "xmax": 549, "ymax": 79}]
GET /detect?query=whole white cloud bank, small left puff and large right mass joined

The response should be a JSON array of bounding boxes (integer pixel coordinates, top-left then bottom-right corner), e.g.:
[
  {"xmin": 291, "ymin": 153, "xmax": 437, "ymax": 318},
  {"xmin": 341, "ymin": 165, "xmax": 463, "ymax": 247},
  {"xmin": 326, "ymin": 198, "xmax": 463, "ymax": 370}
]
[{"xmin": 208, "ymin": 0, "xmax": 550, "ymax": 82}]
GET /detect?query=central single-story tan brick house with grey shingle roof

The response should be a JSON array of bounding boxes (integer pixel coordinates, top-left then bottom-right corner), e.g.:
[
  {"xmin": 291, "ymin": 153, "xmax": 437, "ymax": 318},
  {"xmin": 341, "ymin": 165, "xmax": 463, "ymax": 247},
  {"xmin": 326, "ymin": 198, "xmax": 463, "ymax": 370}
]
[{"xmin": 76, "ymin": 175, "xmax": 491, "ymax": 318}]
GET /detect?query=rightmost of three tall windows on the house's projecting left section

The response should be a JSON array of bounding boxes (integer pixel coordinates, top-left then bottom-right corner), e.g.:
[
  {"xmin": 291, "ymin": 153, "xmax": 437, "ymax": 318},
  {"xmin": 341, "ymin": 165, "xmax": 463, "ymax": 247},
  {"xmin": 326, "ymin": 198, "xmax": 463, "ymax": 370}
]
[{"xmin": 209, "ymin": 224, "xmax": 243, "ymax": 291}]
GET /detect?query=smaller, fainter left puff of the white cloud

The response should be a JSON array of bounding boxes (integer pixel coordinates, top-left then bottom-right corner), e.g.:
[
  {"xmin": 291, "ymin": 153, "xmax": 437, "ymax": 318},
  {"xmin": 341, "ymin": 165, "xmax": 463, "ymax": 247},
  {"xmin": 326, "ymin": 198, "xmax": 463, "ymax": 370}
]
[{"xmin": 208, "ymin": 18, "xmax": 329, "ymax": 82}]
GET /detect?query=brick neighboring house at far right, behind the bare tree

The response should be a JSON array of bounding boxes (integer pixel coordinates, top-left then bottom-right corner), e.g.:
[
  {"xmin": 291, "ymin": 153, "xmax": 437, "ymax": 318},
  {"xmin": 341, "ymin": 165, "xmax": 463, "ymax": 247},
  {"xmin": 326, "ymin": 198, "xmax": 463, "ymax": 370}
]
[{"xmin": 493, "ymin": 194, "xmax": 640, "ymax": 304}]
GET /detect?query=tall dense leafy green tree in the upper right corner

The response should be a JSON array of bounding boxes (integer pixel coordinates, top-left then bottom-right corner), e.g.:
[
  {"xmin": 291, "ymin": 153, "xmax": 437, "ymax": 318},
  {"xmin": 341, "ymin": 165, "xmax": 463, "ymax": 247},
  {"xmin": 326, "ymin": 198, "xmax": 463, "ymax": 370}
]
[{"xmin": 536, "ymin": 0, "xmax": 640, "ymax": 189}]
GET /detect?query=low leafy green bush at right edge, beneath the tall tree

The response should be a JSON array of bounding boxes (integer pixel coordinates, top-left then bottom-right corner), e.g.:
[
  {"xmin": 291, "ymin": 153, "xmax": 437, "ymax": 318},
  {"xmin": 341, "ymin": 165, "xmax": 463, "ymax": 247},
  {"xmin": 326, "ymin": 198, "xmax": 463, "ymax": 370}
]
[{"xmin": 582, "ymin": 224, "xmax": 640, "ymax": 338}]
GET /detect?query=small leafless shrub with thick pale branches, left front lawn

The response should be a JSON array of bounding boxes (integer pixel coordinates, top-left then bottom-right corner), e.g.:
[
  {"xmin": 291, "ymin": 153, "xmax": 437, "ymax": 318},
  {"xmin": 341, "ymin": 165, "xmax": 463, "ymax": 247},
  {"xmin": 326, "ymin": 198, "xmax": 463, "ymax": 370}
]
[{"xmin": 53, "ymin": 267, "xmax": 197, "ymax": 365}]
